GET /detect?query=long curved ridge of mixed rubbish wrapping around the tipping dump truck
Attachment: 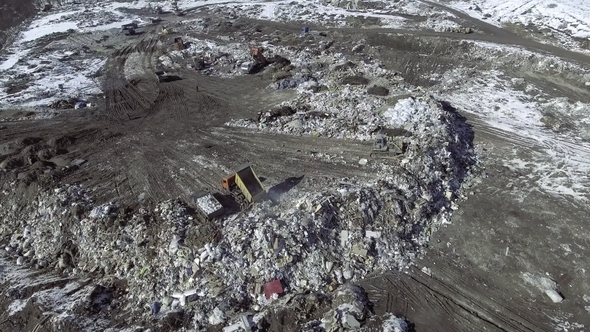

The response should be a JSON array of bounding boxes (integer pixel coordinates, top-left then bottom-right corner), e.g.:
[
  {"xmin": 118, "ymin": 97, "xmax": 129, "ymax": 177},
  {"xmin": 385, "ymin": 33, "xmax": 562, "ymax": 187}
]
[{"xmin": 0, "ymin": 89, "xmax": 475, "ymax": 326}]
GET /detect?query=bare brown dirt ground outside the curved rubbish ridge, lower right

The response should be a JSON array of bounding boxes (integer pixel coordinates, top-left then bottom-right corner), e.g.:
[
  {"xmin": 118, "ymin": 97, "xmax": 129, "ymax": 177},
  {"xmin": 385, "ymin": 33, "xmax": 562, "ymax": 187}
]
[{"xmin": 361, "ymin": 118, "xmax": 590, "ymax": 331}]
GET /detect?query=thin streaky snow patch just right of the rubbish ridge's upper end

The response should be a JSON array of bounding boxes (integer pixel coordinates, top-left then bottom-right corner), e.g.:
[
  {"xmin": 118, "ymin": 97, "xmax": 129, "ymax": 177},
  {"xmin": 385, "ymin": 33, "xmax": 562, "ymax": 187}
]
[{"xmin": 438, "ymin": 68, "xmax": 590, "ymax": 200}]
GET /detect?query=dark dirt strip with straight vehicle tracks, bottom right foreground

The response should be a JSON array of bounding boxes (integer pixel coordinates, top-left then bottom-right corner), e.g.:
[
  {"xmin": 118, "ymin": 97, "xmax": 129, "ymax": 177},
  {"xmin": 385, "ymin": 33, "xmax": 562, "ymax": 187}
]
[{"xmin": 361, "ymin": 264, "xmax": 549, "ymax": 332}]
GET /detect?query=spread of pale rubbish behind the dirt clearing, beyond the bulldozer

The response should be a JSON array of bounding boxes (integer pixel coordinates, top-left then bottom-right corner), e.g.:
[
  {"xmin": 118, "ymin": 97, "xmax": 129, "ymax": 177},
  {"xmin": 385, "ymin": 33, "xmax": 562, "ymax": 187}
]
[{"xmin": 231, "ymin": 57, "xmax": 411, "ymax": 140}]
